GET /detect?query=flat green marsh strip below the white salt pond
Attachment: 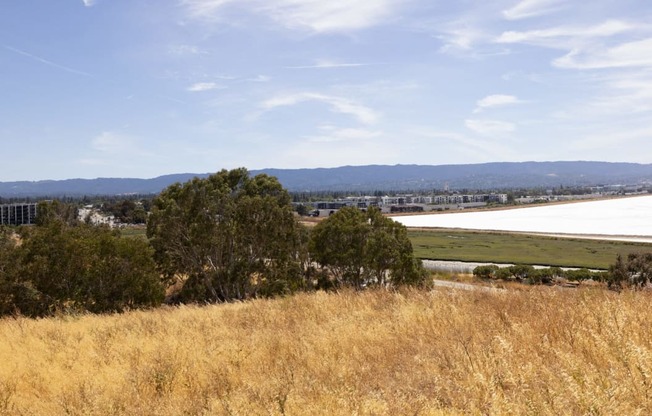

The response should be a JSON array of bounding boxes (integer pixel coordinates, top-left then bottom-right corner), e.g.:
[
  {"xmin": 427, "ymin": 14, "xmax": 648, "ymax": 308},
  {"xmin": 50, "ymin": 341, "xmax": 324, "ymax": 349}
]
[{"xmin": 408, "ymin": 229, "xmax": 652, "ymax": 269}]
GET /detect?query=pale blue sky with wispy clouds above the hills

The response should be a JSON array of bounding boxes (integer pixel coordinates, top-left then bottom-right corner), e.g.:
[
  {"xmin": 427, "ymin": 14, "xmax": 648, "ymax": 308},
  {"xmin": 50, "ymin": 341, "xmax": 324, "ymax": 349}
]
[{"xmin": 0, "ymin": 0, "xmax": 652, "ymax": 181}]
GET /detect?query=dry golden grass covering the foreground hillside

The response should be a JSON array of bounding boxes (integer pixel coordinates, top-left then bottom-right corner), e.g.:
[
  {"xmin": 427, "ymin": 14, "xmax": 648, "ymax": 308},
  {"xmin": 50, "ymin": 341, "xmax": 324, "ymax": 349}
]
[{"xmin": 0, "ymin": 287, "xmax": 652, "ymax": 415}]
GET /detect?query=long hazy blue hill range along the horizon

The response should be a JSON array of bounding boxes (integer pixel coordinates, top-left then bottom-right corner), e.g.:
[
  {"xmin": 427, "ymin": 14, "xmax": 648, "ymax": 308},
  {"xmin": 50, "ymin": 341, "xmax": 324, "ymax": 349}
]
[{"xmin": 0, "ymin": 161, "xmax": 652, "ymax": 198}]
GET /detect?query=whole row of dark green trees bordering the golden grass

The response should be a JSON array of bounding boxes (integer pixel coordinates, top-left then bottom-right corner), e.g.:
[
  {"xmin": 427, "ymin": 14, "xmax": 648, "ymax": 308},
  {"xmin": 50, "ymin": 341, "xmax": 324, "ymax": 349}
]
[{"xmin": 0, "ymin": 168, "xmax": 428, "ymax": 316}]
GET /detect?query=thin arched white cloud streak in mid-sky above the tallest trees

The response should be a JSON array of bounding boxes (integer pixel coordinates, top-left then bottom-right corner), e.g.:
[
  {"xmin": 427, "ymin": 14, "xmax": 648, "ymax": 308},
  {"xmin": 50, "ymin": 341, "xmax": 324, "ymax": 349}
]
[{"xmin": 261, "ymin": 92, "xmax": 380, "ymax": 124}]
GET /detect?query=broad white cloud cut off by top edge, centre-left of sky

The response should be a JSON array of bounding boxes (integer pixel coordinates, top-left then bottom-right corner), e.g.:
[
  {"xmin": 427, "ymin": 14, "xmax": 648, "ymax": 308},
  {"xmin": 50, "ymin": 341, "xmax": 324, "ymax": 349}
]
[{"xmin": 181, "ymin": 0, "xmax": 405, "ymax": 33}]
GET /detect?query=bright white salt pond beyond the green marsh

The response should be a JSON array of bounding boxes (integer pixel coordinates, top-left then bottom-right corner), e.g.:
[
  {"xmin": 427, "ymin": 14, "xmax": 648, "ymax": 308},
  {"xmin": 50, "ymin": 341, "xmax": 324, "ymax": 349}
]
[{"xmin": 392, "ymin": 195, "xmax": 652, "ymax": 242}]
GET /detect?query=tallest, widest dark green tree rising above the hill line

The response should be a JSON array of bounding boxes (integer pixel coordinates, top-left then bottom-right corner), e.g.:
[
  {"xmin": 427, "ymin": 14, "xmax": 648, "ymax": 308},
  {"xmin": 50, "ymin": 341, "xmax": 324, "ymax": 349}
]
[{"xmin": 147, "ymin": 168, "xmax": 303, "ymax": 302}]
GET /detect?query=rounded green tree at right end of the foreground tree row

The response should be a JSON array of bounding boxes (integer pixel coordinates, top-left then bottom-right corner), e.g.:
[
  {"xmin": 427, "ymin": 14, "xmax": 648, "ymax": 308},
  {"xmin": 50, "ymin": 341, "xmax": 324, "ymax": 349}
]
[{"xmin": 310, "ymin": 207, "xmax": 428, "ymax": 289}]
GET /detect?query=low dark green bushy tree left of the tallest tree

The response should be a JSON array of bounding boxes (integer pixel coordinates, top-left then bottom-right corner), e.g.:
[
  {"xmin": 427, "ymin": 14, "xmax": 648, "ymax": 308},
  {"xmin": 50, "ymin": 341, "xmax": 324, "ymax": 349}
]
[{"xmin": 14, "ymin": 220, "xmax": 164, "ymax": 316}]
